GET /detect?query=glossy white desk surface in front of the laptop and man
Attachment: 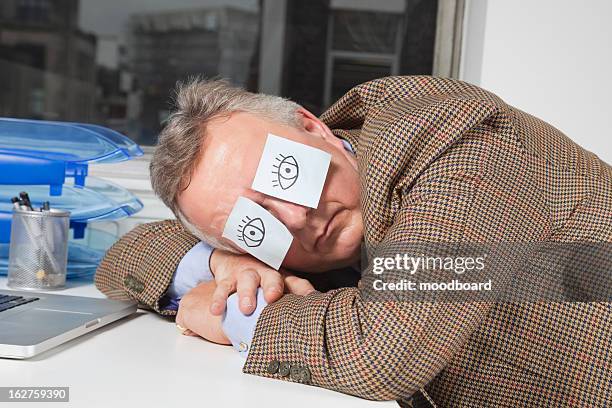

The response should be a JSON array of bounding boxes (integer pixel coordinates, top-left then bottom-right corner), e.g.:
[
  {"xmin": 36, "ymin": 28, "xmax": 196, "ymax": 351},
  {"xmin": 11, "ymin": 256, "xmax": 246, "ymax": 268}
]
[{"xmin": 0, "ymin": 277, "xmax": 397, "ymax": 408}]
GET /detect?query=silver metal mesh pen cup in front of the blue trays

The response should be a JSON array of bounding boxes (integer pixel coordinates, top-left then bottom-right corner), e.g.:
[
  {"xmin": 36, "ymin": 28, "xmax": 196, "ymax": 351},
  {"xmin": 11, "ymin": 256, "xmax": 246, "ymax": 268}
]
[{"xmin": 7, "ymin": 209, "xmax": 70, "ymax": 290}]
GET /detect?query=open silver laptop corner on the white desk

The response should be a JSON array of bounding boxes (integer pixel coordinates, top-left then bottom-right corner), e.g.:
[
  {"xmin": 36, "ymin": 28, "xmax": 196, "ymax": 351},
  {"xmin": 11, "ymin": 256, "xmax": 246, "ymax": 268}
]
[{"xmin": 0, "ymin": 290, "xmax": 136, "ymax": 359}]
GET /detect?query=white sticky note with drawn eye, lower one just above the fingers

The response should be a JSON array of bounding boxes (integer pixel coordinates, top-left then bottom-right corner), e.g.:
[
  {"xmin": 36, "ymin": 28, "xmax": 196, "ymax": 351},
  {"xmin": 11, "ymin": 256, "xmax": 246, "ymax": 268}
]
[{"xmin": 223, "ymin": 197, "xmax": 293, "ymax": 269}]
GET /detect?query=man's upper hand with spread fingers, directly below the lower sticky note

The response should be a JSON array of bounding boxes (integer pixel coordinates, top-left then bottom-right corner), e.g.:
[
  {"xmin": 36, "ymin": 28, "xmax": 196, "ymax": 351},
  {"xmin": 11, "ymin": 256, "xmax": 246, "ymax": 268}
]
[{"xmin": 210, "ymin": 249, "xmax": 315, "ymax": 316}]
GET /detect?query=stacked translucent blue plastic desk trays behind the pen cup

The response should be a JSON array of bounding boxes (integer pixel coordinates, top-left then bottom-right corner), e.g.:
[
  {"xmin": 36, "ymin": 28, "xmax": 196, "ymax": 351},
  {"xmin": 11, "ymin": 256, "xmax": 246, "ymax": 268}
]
[{"xmin": 0, "ymin": 118, "xmax": 142, "ymax": 278}]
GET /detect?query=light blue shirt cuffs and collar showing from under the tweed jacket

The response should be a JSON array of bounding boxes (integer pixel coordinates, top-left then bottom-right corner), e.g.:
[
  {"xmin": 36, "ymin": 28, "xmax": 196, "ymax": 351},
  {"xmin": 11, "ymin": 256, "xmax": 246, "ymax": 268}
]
[{"xmin": 164, "ymin": 139, "xmax": 354, "ymax": 358}]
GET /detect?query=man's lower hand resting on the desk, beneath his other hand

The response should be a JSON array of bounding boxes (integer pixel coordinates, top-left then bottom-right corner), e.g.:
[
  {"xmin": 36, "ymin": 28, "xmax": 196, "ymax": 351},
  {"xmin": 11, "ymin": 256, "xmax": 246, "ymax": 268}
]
[{"xmin": 176, "ymin": 281, "xmax": 230, "ymax": 344}]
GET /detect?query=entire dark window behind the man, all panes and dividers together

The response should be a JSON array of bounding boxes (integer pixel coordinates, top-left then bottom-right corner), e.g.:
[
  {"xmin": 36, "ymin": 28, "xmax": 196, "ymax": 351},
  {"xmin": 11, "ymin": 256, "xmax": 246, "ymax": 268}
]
[{"xmin": 0, "ymin": 0, "xmax": 437, "ymax": 145}]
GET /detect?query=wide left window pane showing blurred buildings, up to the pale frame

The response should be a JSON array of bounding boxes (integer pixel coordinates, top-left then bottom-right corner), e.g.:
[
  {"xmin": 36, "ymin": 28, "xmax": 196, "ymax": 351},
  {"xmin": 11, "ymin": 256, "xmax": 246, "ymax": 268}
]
[{"xmin": 0, "ymin": 0, "xmax": 260, "ymax": 145}]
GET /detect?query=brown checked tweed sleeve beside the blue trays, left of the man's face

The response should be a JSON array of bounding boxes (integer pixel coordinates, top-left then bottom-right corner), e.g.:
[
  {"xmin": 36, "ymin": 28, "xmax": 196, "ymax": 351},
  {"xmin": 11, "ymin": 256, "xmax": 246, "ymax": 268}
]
[{"xmin": 95, "ymin": 220, "xmax": 199, "ymax": 315}]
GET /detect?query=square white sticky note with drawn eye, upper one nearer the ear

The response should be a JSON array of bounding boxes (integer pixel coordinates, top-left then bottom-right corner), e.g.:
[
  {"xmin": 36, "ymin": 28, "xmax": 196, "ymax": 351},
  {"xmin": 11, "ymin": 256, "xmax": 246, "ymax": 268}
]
[{"xmin": 251, "ymin": 133, "xmax": 331, "ymax": 208}]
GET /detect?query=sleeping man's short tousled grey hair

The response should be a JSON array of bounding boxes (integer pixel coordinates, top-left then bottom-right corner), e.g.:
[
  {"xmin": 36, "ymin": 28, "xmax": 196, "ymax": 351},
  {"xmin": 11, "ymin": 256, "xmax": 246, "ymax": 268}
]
[{"xmin": 149, "ymin": 78, "xmax": 300, "ymax": 250}]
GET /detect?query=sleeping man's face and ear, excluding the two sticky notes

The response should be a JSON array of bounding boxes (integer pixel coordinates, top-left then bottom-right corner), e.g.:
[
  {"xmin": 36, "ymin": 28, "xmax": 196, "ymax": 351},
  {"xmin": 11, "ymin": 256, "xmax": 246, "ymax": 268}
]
[{"xmin": 178, "ymin": 111, "xmax": 363, "ymax": 272}]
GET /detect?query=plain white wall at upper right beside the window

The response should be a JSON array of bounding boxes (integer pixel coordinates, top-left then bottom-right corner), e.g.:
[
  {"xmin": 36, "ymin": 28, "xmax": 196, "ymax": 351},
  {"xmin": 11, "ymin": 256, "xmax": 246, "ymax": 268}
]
[{"xmin": 460, "ymin": 0, "xmax": 612, "ymax": 164}]
